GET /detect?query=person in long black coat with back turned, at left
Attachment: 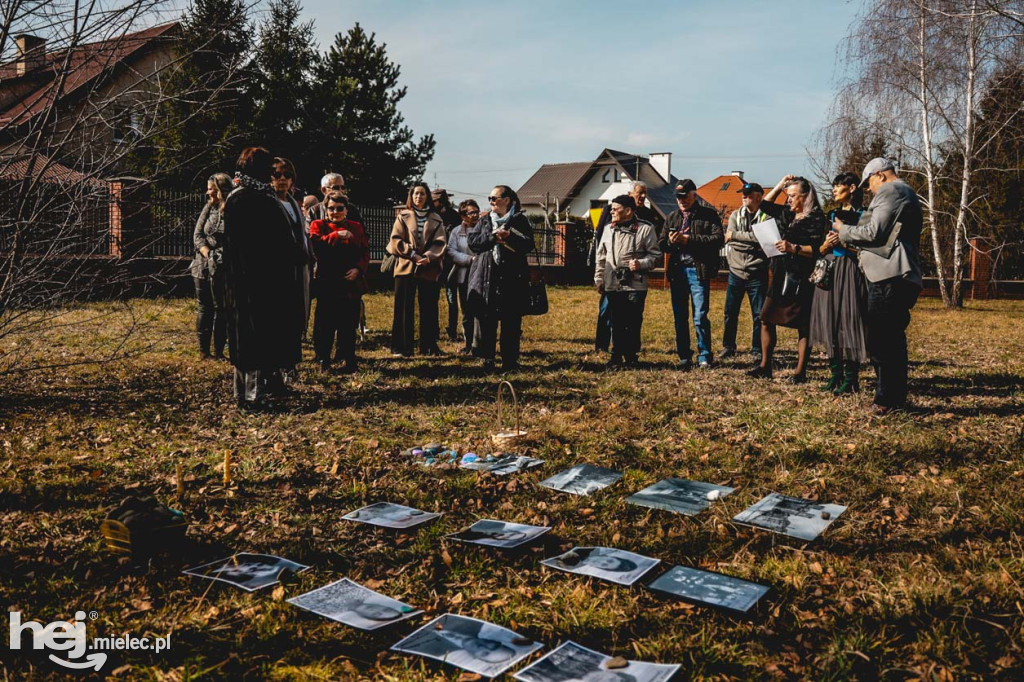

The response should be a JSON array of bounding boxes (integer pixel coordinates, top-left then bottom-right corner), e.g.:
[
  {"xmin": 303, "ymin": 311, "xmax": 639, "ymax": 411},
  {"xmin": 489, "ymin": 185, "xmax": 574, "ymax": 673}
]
[{"xmin": 224, "ymin": 147, "xmax": 305, "ymax": 408}]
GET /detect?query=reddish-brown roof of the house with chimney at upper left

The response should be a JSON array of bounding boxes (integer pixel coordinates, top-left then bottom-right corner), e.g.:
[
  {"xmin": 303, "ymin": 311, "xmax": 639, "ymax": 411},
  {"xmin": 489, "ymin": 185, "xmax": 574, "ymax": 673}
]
[{"xmin": 0, "ymin": 22, "xmax": 179, "ymax": 123}]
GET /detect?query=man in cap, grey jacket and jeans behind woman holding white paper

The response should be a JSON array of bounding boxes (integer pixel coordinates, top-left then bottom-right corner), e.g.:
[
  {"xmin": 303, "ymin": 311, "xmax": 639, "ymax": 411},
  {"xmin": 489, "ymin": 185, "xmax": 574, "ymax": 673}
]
[{"xmin": 719, "ymin": 182, "xmax": 779, "ymax": 365}]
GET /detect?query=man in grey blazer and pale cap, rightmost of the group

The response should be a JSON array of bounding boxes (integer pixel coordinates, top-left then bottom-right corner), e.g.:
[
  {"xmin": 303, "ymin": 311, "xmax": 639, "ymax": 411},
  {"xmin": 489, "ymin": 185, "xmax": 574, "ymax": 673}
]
[{"xmin": 835, "ymin": 158, "xmax": 924, "ymax": 415}]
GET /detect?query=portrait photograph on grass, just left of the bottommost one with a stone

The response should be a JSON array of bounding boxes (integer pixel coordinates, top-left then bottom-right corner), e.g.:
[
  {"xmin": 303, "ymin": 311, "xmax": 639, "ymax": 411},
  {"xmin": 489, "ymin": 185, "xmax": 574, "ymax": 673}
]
[{"xmin": 391, "ymin": 613, "xmax": 541, "ymax": 677}]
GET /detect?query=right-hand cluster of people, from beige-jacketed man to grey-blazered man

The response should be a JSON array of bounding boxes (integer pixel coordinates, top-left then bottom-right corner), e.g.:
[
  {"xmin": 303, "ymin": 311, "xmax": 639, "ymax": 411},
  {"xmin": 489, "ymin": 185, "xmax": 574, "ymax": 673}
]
[{"xmin": 592, "ymin": 159, "xmax": 923, "ymax": 413}]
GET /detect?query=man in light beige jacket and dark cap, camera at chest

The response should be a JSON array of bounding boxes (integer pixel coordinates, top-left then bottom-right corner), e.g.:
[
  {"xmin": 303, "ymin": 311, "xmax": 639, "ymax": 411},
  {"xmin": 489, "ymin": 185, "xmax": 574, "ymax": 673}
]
[{"xmin": 594, "ymin": 195, "xmax": 662, "ymax": 367}]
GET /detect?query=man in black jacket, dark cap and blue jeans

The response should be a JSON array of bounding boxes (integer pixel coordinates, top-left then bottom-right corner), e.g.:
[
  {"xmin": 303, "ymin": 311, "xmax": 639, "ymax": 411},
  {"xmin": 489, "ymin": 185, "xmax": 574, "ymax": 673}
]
[{"xmin": 658, "ymin": 179, "xmax": 724, "ymax": 370}]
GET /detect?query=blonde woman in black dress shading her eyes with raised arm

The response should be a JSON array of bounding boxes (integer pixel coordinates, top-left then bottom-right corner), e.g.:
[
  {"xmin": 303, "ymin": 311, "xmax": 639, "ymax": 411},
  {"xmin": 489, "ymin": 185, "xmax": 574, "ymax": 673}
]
[{"xmin": 748, "ymin": 175, "xmax": 828, "ymax": 384}]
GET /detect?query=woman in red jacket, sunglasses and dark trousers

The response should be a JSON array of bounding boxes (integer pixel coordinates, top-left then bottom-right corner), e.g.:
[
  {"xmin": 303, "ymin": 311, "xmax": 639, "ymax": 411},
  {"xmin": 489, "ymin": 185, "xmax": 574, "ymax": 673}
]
[{"xmin": 309, "ymin": 191, "xmax": 370, "ymax": 374}]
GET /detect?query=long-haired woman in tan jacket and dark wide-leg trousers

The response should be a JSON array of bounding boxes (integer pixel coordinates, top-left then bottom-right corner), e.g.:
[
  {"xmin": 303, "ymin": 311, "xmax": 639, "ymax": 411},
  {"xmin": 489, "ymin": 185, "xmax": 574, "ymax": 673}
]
[{"xmin": 387, "ymin": 182, "xmax": 447, "ymax": 357}]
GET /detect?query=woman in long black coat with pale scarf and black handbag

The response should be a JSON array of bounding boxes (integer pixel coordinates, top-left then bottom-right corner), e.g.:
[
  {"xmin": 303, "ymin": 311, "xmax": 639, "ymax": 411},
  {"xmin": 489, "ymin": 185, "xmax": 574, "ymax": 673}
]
[{"xmin": 467, "ymin": 184, "xmax": 534, "ymax": 371}]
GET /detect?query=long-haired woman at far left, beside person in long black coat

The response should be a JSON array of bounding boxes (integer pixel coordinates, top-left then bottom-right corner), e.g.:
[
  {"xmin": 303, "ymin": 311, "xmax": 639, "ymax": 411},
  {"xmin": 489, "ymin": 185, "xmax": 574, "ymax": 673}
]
[{"xmin": 188, "ymin": 173, "xmax": 232, "ymax": 359}]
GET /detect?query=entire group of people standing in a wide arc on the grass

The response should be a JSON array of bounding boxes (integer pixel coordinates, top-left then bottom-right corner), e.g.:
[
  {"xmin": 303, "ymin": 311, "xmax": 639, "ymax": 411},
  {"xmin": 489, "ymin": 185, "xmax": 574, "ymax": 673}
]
[{"xmin": 191, "ymin": 147, "xmax": 923, "ymax": 412}]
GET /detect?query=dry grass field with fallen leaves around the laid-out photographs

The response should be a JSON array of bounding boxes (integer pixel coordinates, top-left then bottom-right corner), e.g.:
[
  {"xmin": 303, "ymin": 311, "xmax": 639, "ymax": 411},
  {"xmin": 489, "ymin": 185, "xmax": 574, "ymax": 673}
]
[{"xmin": 0, "ymin": 288, "xmax": 1024, "ymax": 682}]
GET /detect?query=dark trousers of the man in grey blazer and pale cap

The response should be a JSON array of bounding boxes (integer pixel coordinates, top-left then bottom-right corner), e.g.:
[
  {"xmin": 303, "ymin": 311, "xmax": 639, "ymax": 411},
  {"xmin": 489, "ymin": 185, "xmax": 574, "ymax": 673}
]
[{"xmin": 866, "ymin": 278, "xmax": 921, "ymax": 408}]
